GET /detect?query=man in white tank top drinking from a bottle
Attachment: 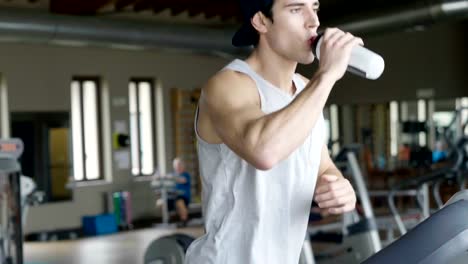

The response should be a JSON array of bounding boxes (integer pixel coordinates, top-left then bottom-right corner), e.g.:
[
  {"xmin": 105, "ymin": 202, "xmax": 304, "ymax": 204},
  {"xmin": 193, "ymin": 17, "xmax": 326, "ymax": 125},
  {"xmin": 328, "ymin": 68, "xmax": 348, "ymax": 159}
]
[{"xmin": 185, "ymin": 0, "xmax": 363, "ymax": 264}]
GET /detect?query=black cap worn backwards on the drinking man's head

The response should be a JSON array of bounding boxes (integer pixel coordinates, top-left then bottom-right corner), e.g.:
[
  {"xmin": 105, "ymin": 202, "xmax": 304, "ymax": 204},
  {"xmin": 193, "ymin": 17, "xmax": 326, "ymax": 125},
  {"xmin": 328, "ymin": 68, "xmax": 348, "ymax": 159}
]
[{"xmin": 232, "ymin": 0, "xmax": 274, "ymax": 47}]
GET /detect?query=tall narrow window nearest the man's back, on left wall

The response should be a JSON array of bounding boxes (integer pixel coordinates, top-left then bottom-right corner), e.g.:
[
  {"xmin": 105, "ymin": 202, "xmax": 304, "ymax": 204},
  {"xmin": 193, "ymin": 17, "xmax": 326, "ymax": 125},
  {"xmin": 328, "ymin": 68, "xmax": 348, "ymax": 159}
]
[{"xmin": 129, "ymin": 79, "xmax": 156, "ymax": 176}]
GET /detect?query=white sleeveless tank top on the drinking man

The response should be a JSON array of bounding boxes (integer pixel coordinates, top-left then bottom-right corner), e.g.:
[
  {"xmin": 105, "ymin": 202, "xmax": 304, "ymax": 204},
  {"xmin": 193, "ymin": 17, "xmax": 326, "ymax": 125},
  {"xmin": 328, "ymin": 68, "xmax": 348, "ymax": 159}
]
[{"xmin": 185, "ymin": 60, "xmax": 325, "ymax": 264}]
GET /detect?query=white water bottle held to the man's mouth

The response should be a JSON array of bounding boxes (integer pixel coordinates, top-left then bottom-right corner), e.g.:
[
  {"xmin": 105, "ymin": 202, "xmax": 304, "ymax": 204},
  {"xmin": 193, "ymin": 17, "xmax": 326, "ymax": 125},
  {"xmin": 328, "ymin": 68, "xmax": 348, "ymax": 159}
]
[{"xmin": 312, "ymin": 35, "xmax": 385, "ymax": 80}]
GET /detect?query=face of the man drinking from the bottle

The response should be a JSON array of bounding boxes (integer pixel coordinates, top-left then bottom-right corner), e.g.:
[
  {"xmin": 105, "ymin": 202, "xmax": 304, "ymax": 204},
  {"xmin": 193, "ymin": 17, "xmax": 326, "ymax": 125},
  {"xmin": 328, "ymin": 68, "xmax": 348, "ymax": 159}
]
[{"xmin": 265, "ymin": 0, "xmax": 320, "ymax": 64}]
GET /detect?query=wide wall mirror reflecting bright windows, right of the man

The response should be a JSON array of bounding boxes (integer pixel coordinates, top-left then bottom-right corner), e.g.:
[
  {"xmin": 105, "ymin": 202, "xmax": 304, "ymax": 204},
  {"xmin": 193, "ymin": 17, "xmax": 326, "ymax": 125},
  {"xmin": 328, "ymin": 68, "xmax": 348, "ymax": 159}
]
[{"xmin": 324, "ymin": 98, "xmax": 468, "ymax": 170}]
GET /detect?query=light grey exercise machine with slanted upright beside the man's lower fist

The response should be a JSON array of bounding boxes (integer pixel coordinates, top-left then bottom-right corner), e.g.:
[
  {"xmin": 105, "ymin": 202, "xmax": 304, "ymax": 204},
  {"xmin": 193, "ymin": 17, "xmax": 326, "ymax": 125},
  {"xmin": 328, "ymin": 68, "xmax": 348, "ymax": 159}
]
[{"xmin": 300, "ymin": 144, "xmax": 382, "ymax": 264}]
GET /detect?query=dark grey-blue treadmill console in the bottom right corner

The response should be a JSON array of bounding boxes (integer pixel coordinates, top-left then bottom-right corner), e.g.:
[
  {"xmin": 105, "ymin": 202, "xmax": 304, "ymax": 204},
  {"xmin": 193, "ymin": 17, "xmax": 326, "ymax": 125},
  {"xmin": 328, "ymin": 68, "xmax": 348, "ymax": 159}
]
[{"xmin": 363, "ymin": 190, "xmax": 468, "ymax": 264}]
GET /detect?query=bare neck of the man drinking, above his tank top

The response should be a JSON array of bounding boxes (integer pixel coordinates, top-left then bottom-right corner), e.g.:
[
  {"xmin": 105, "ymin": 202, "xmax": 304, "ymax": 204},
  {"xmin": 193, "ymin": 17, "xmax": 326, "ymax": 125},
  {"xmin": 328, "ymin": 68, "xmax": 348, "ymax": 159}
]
[{"xmin": 246, "ymin": 49, "xmax": 297, "ymax": 95}]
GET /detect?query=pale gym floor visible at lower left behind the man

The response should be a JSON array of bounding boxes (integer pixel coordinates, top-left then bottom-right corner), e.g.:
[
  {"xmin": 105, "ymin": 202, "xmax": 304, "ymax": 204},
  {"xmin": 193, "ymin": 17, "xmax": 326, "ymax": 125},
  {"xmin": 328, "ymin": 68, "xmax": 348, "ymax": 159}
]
[{"xmin": 24, "ymin": 227, "xmax": 203, "ymax": 264}]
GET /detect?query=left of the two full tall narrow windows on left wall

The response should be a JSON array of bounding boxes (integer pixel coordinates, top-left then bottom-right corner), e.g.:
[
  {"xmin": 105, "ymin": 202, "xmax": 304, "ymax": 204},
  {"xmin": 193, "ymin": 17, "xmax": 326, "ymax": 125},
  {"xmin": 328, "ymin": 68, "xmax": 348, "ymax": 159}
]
[{"xmin": 71, "ymin": 78, "xmax": 104, "ymax": 181}]
